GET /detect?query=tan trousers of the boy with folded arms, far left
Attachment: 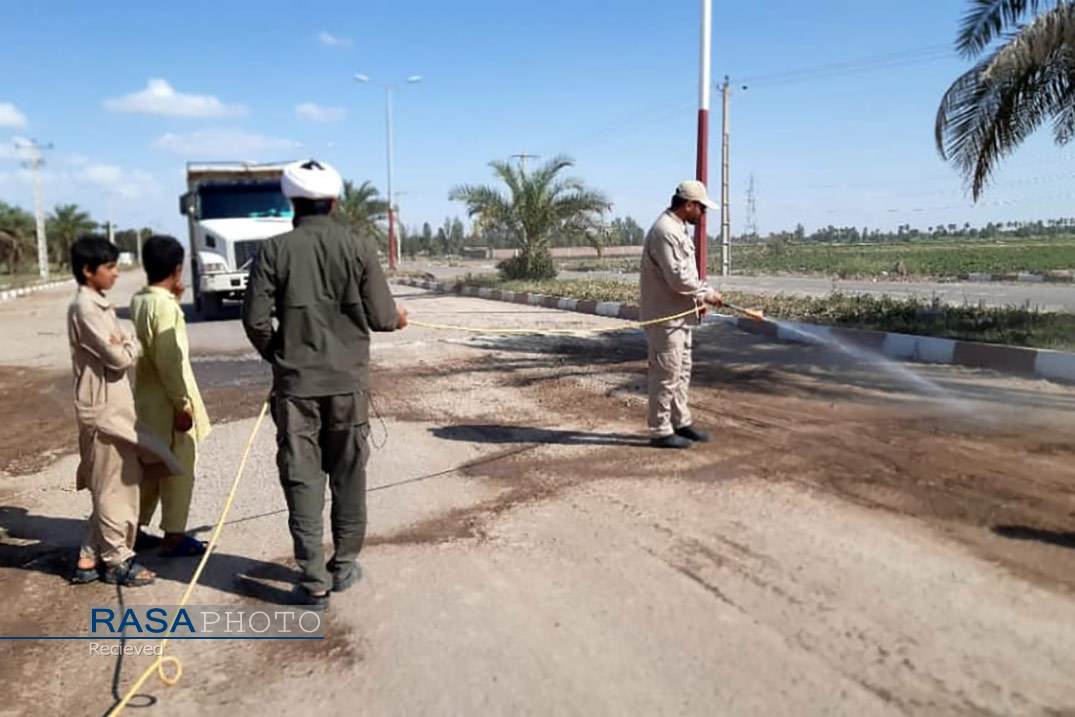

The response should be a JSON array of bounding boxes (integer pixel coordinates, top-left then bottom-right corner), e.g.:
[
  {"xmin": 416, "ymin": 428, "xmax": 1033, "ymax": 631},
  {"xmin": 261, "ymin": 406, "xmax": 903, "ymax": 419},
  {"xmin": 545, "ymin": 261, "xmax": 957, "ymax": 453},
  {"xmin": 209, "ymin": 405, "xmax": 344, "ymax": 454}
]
[{"xmin": 78, "ymin": 428, "xmax": 142, "ymax": 565}]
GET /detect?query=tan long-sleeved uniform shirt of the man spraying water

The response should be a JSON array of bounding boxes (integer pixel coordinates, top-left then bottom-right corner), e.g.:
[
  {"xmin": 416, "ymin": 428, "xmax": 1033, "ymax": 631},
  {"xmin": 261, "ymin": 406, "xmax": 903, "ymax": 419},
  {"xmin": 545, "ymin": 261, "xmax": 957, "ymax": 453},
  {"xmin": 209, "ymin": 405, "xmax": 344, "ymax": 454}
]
[{"xmin": 639, "ymin": 210, "xmax": 711, "ymax": 328}]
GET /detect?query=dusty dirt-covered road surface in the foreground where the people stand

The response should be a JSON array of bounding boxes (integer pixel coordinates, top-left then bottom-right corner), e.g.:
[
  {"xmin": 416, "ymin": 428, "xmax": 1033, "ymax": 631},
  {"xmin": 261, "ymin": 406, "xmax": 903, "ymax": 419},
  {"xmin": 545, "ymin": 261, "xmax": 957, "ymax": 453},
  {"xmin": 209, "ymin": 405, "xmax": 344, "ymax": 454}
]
[{"xmin": 0, "ymin": 275, "xmax": 1075, "ymax": 715}]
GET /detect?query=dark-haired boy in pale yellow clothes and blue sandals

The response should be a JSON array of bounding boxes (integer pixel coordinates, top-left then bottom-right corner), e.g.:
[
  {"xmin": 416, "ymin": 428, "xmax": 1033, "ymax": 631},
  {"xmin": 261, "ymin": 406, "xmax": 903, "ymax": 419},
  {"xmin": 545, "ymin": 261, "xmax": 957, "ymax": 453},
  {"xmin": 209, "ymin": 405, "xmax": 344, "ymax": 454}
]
[{"xmin": 131, "ymin": 236, "xmax": 211, "ymax": 558}]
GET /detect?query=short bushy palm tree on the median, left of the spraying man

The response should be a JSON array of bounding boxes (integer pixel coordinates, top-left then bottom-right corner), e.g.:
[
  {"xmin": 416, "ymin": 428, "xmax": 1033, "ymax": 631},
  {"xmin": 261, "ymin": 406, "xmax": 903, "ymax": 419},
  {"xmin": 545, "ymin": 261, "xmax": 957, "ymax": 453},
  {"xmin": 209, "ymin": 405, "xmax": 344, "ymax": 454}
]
[{"xmin": 448, "ymin": 156, "xmax": 612, "ymax": 278}]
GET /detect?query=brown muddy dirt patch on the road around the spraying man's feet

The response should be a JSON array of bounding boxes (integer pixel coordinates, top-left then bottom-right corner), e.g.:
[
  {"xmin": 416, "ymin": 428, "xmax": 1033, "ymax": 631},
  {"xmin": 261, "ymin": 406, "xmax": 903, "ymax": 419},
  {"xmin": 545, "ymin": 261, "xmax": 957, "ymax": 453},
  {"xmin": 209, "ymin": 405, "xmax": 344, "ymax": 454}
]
[{"xmin": 363, "ymin": 343, "xmax": 1075, "ymax": 588}]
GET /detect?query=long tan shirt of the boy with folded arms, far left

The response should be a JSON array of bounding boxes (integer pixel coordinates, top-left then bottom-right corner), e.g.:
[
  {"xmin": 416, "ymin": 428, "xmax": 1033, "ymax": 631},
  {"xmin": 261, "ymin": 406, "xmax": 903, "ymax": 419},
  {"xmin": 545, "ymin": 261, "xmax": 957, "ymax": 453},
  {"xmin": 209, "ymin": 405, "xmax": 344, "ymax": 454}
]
[{"xmin": 68, "ymin": 286, "xmax": 182, "ymax": 489}]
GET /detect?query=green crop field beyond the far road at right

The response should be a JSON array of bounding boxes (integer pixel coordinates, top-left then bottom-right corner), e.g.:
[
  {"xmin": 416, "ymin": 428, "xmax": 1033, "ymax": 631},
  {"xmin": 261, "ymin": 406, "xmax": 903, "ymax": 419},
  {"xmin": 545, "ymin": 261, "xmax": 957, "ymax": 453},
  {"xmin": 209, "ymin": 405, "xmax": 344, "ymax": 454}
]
[{"xmin": 558, "ymin": 239, "xmax": 1075, "ymax": 278}]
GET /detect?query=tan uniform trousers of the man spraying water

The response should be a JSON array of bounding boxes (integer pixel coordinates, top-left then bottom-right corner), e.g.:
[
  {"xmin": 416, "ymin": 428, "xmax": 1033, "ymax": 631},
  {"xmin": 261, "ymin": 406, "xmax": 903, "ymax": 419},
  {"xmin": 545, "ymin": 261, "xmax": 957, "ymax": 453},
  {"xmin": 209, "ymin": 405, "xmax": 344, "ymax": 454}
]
[{"xmin": 646, "ymin": 324, "xmax": 693, "ymax": 439}]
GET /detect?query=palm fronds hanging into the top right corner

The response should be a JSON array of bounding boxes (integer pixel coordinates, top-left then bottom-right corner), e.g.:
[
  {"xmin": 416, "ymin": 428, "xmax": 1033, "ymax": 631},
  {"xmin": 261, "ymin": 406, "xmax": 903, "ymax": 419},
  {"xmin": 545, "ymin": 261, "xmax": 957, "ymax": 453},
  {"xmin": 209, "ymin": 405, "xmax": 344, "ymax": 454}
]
[{"xmin": 935, "ymin": 0, "xmax": 1075, "ymax": 200}]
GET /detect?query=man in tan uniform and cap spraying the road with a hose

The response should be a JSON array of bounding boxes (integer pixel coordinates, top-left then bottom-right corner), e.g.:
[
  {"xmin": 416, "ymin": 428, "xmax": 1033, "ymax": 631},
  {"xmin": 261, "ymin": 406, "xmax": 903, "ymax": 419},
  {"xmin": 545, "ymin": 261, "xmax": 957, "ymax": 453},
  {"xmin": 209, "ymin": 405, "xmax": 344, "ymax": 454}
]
[{"xmin": 639, "ymin": 180, "xmax": 720, "ymax": 448}]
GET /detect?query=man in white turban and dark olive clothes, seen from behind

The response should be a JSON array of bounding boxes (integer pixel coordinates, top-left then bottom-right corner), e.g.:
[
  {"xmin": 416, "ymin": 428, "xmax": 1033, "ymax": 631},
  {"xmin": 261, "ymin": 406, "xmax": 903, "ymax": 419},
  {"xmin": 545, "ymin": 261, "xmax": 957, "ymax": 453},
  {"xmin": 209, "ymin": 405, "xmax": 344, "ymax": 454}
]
[{"xmin": 243, "ymin": 160, "xmax": 407, "ymax": 605}]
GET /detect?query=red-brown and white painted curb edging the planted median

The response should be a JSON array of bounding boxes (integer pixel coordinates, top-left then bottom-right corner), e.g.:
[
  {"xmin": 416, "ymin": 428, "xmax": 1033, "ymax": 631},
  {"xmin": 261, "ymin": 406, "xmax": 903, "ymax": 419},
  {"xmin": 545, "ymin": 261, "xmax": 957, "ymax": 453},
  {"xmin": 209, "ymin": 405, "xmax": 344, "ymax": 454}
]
[{"xmin": 392, "ymin": 278, "xmax": 1075, "ymax": 384}]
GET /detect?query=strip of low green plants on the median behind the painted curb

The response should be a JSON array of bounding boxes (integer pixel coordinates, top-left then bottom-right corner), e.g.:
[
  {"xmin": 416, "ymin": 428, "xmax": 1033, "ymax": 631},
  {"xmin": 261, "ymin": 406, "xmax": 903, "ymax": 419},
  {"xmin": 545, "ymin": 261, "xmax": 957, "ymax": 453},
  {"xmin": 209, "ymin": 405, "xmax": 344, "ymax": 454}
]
[{"xmin": 461, "ymin": 275, "xmax": 1075, "ymax": 350}]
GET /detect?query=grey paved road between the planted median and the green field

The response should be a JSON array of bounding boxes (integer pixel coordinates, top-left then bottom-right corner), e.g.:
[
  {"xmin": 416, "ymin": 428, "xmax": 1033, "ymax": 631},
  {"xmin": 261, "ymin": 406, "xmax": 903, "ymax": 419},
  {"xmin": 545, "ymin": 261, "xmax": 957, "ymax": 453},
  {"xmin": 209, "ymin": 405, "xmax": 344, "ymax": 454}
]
[{"xmin": 409, "ymin": 262, "xmax": 1075, "ymax": 313}]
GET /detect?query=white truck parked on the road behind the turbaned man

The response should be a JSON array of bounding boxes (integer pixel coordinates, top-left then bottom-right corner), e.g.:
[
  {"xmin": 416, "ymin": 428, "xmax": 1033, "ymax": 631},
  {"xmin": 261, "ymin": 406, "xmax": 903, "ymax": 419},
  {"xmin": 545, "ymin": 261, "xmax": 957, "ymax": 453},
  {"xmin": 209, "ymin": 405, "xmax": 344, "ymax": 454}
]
[{"xmin": 180, "ymin": 162, "xmax": 292, "ymax": 319}]
